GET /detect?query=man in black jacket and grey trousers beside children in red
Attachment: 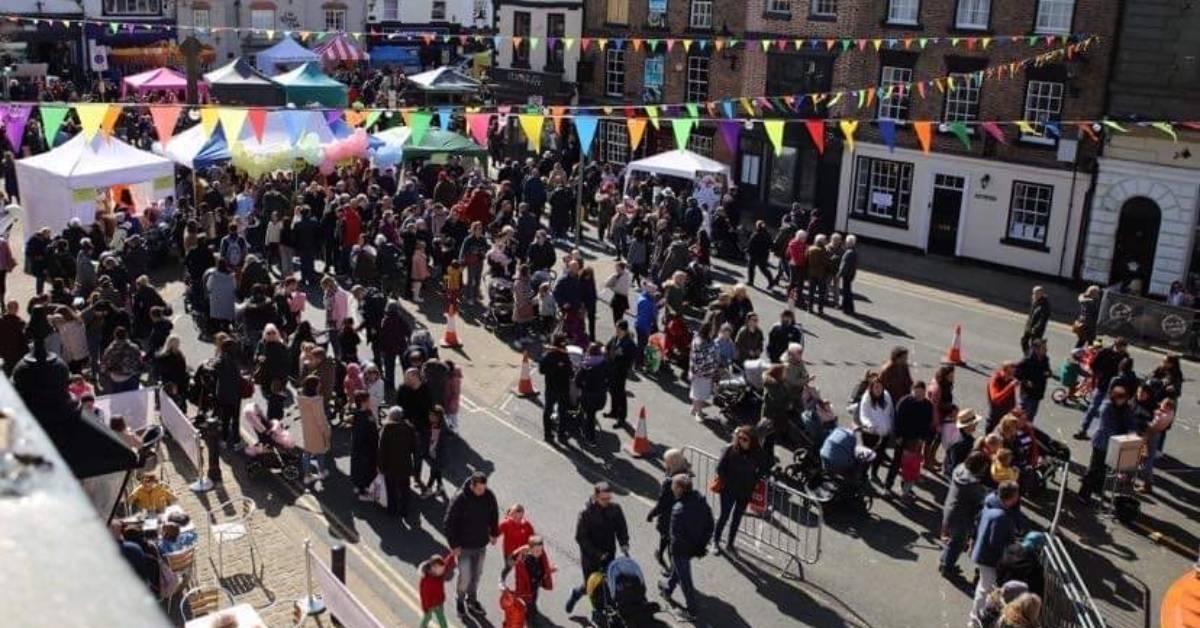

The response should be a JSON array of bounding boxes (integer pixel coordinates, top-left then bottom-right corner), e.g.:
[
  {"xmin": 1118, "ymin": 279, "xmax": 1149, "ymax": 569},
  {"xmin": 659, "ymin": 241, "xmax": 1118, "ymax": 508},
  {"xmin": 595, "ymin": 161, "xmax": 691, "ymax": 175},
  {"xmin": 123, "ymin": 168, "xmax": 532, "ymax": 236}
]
[{"xmin": 445, "ymin": 471, "xmax": 500, "ymax": 617}]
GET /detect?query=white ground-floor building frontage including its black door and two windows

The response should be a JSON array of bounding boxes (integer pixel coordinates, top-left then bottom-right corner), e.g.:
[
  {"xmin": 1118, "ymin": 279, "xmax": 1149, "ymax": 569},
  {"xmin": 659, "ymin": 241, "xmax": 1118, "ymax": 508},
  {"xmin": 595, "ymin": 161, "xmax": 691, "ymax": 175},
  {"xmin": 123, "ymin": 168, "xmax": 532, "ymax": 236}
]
[{"xmin": 835, "ymin": 140, "xmax": 1091, "ymax": 277}]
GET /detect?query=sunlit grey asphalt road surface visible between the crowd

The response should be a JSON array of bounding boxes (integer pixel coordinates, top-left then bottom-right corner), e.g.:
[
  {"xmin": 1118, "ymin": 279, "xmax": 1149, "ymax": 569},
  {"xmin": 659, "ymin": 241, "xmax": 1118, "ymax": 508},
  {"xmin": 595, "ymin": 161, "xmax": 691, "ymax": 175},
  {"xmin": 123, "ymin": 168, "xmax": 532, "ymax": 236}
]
[{"xmin": 142, "ymin": 235, "xmax": 1200, "ymax": 628}]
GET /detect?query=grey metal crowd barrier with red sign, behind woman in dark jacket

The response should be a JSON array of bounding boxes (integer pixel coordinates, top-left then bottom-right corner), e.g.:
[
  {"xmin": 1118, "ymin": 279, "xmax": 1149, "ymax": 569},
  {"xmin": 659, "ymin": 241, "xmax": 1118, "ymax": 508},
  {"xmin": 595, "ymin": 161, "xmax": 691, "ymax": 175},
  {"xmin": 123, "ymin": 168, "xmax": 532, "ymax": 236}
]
[{"xmin": 683, "ymin": 447, "xmax": 824, "ymax": 578}]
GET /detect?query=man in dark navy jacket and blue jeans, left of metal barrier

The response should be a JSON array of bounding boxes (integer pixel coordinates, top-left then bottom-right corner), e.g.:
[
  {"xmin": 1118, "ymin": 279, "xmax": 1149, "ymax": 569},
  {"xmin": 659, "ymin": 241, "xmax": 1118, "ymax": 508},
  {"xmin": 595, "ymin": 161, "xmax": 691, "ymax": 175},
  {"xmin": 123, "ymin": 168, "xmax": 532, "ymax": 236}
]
[{"xmin": 659, "ymin": 473, "xmax": 713, "ymax": 621}]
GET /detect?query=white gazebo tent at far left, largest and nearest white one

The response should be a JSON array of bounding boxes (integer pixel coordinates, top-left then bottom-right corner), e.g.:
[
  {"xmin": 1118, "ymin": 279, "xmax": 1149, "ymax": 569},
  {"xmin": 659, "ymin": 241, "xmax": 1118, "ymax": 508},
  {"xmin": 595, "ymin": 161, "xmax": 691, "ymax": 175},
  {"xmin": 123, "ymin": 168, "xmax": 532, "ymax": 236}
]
[{"xmin": 17, "ymin": 133, "xmax": 175, "ymax": 232}]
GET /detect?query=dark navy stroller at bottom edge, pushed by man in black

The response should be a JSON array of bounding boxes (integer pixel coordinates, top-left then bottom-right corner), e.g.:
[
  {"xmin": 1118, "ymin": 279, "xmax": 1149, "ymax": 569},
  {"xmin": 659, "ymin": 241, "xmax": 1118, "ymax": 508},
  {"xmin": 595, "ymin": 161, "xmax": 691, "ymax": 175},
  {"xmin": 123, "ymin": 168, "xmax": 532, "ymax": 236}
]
[{"xmin": 587, "ymin": 556, "xmax": 662, "ymax": 628}]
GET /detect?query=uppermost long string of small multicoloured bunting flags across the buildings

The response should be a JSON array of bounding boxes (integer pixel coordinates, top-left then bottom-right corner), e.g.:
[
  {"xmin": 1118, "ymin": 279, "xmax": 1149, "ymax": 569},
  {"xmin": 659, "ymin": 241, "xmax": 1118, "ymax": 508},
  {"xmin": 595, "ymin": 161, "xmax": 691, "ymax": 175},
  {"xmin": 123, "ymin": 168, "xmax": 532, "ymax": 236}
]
[{"xmin": 0, "ymin": 13, "xmax": 1091, "ymax": 53}]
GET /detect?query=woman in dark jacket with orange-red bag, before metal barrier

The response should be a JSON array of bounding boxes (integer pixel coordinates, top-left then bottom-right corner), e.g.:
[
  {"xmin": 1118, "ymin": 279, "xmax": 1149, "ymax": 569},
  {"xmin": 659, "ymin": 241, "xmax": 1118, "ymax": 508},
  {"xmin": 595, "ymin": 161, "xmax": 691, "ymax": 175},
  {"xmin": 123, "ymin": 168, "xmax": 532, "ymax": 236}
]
[{"xmin": 708, "ymin": 425, "xmax": 768, "ymax": 554}]
